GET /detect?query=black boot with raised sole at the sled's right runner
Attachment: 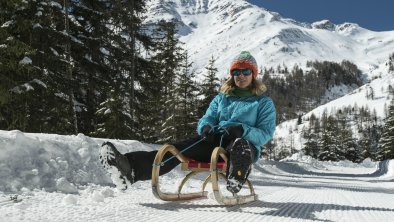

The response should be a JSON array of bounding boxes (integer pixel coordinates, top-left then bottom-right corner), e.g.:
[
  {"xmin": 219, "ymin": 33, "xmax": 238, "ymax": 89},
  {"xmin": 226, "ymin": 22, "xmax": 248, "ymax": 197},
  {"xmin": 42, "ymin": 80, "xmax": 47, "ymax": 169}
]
[{"xmin": 226, "ymin": 138, "xmax": 254, "ymax": 193}]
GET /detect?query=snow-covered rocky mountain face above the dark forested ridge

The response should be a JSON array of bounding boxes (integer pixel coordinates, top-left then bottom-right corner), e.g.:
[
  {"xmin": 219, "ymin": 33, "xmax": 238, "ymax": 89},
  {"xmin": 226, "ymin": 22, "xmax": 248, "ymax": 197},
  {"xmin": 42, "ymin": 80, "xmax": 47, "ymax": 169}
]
[{"xmin": 145, "ymin": 0, "xmax": 394, "ymax": 77}]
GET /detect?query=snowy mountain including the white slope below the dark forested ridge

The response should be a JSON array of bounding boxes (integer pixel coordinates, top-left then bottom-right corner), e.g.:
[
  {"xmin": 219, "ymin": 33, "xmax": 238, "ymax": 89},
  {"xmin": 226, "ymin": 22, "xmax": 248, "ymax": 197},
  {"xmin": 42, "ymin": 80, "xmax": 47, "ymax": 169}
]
[{"xmin": 145, "ymin": 0, "xmax": 394, "ymax": 154}]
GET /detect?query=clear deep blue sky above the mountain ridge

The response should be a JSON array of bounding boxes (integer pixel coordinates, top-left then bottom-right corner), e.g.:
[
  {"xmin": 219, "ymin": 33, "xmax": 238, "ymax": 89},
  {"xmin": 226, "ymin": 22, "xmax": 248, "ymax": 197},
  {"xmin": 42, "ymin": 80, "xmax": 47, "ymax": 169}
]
[{"xmin": 248, "ymin": 0, "xmax": 394, "ymax": 31}]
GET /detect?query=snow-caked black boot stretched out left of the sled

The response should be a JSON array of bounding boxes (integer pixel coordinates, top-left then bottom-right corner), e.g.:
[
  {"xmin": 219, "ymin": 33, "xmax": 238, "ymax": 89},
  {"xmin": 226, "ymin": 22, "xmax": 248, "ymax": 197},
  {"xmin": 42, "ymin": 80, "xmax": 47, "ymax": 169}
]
[{"xmin": 99, "ymin": 142, "xmax": 135, "ymax": 190}]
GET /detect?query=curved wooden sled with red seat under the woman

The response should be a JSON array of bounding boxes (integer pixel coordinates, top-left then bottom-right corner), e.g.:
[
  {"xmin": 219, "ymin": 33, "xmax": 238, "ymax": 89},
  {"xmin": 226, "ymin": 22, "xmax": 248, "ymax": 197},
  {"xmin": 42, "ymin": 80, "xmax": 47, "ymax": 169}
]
[{"xmin": 152, "ymin": 144, "xmax": 257, "ymax": 205}]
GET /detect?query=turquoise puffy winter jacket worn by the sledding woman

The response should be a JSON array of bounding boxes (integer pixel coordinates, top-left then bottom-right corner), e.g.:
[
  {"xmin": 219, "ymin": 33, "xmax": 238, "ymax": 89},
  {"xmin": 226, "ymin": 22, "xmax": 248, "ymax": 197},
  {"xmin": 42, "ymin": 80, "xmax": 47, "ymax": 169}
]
[{"xmin": 197, "ymin": 93, "xmax": 276, "ymax": 161}]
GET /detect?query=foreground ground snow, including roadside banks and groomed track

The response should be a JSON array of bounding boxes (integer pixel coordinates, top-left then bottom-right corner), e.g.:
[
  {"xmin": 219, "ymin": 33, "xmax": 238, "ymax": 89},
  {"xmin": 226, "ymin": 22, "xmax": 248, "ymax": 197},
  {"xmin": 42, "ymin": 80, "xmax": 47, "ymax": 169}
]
[{"xmin": 0, "ymin": 131, "xmax": 394, "ymax": 222}]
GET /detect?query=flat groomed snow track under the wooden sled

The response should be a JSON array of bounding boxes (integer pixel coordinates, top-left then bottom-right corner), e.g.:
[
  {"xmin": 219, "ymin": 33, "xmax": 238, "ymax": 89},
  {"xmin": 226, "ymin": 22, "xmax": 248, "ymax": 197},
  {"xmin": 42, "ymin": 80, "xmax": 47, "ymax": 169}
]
[{"xmin": 0, "ymin": 162, "xmax": 394, "ymax": 222}]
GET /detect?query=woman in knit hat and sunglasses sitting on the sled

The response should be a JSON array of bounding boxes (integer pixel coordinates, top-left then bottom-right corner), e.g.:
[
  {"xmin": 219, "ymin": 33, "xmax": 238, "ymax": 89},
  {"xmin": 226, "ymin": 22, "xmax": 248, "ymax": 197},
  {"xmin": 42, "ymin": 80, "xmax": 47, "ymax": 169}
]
[{"xmin": 100, "ymin": 51, "xmax": 276, "ymax": 193}]
